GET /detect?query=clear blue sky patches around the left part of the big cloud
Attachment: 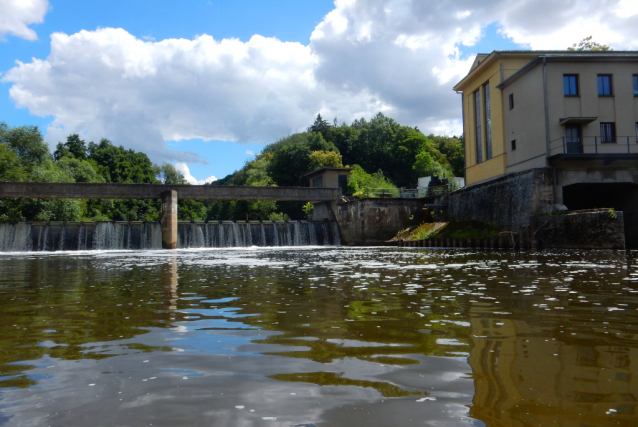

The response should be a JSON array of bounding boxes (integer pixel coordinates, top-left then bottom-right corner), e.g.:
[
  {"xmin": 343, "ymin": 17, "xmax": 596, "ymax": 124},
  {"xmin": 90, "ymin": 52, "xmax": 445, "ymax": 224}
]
[{"xmin": 0, "ymin": 0, "xmax": 333, "ymax": 179}]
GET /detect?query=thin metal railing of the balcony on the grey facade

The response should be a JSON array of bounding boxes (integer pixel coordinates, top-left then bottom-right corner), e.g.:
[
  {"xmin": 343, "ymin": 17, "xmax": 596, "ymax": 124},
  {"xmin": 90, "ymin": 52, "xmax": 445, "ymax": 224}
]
[{"xmin": 549, "ymin": 136, "xmax": 638, "ymax": 157}]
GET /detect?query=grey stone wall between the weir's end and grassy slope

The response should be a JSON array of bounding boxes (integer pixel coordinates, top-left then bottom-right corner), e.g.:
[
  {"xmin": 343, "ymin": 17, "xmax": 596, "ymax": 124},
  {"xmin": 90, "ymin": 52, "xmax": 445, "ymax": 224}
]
[{"xmin": 337, "ymin": 198, "xmax": 425, "ymax": 246}]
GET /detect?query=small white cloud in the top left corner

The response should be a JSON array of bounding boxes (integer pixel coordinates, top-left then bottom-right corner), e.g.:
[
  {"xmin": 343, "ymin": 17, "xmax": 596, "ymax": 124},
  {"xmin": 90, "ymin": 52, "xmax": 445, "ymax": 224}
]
[{"xmin": 0, "ymin": 0, "xmax": 49, "ymax": 40}]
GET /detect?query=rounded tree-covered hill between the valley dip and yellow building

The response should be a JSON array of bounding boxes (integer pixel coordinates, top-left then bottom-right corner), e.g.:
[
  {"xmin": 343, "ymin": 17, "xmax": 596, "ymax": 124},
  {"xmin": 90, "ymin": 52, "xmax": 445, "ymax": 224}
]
[{"xmin": 207, "ymin": 113, "xmax": 464, "ymax": 219}]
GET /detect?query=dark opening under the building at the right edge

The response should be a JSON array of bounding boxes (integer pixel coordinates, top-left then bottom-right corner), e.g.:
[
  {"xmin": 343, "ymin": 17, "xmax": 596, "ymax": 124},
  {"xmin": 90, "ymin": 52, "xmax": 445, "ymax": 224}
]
[{"xmin": 563, "ymin": 182, "xmax": 638, "ymax": 247}]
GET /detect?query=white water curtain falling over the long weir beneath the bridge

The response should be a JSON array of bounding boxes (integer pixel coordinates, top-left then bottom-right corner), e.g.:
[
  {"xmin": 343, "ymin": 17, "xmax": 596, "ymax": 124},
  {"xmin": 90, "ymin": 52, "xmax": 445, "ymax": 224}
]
[{"xmin": 0, "ymin": 221, "xmax": 341, "ymax": 252}]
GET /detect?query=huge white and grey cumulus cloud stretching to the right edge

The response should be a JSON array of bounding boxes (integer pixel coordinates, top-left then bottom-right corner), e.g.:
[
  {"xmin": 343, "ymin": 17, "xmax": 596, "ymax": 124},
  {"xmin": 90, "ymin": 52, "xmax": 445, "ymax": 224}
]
[{"xmin": 3, "ymin": 0, "xmax": 638, "ymax": 162}]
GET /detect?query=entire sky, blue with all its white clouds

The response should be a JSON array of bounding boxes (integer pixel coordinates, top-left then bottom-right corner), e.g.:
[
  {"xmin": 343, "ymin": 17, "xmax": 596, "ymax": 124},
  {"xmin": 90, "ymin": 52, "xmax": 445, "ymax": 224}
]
[{"xmin": 0, "ymin": 0, "xmax": 638, "ymax": 180}]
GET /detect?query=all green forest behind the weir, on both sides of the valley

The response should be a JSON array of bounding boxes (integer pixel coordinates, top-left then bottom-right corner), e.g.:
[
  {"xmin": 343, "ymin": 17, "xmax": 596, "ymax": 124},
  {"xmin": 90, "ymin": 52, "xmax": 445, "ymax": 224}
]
[{"xmin": 0, "ymin": 113, "xmax": 463, "ymax": 222}]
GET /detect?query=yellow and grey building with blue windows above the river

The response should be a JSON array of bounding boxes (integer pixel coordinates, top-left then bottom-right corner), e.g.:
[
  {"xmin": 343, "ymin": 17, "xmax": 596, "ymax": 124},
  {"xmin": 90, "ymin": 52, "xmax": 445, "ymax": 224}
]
[{"xmin": 454, "ymin": 51, "xmax": 638, "ymax": 187}]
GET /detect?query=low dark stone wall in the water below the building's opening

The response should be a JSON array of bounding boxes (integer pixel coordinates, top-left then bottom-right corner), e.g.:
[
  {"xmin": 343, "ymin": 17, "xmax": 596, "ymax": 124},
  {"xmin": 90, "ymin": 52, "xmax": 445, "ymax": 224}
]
[{"xmin": 534, "ymin": 209, "xmax": 625, "ymax": 249}]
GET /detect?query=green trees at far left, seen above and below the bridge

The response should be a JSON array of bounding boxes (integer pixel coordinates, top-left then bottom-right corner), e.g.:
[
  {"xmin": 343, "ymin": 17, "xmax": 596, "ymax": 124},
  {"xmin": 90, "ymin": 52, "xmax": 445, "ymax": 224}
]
[{"xmin": 0, "ymin": 123, "xmax": 206, "ymax": 222}]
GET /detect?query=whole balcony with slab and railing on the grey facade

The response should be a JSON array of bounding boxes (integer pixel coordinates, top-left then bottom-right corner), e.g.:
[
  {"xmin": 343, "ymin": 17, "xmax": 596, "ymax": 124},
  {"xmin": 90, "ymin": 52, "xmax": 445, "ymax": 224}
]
[{"xmin": 548, "ymin": 135, "xmax": 638, "ymax": 160}]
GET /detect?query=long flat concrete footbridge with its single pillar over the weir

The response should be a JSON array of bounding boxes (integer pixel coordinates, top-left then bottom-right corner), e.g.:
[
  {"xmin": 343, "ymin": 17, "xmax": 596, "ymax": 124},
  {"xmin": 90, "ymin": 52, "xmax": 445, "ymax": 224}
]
[{"xmin": 0, "ymin": 182, "xmax": 341, "ymax": 249}]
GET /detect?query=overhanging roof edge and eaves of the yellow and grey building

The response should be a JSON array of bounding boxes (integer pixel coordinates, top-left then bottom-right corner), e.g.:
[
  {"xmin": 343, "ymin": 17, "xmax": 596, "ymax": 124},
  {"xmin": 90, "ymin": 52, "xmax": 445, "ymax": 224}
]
[{"xmin": 454, "ymin": 50, "xmax": 638, "ymax": 91}]
